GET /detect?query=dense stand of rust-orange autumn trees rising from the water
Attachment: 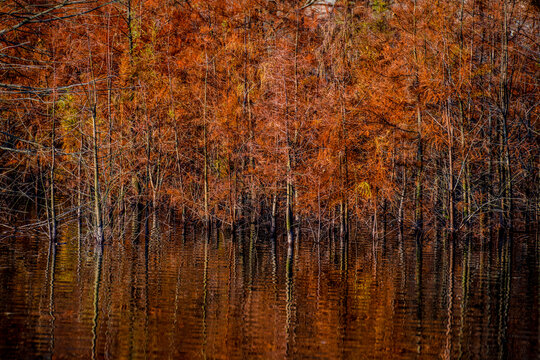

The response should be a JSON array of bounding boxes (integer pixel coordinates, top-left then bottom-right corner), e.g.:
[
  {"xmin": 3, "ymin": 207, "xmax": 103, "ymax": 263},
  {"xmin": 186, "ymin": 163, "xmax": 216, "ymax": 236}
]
[{"xmin": 0, "ymin": 0, "xmax": 540, "ymax": 241}]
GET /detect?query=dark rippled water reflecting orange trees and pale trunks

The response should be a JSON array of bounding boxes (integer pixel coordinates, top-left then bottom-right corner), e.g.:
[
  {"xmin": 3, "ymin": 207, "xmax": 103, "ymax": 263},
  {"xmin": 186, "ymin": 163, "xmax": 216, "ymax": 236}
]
[{"xmin": 0, "ymin": 219, "xmax": 539, "ymax": 359}]
